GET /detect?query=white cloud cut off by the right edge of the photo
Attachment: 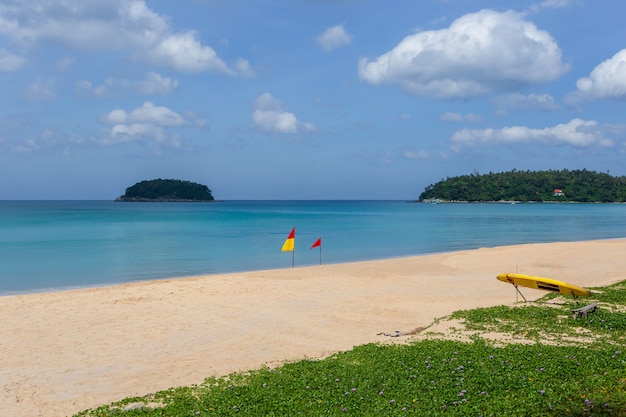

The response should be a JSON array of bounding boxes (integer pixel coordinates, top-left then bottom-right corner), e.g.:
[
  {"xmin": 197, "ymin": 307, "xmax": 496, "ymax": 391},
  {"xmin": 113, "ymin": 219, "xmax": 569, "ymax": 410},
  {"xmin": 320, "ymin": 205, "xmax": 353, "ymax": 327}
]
[{"xmin": 568, "ymin": 49, "xmax": 626, "ymax": 102}]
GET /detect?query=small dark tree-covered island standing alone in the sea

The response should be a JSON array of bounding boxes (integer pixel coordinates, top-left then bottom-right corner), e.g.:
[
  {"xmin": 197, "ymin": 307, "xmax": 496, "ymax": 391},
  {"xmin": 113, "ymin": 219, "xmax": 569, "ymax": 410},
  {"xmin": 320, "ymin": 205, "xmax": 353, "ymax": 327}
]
[{"xmin": 115, "ymin": 178, "xmax": 215, "ymax": 202}]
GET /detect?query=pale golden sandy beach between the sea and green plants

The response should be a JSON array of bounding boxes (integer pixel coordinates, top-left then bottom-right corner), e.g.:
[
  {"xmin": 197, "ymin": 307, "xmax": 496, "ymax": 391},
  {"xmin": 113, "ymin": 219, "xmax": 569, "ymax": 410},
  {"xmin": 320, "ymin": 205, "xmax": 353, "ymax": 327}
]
[{"xmin": 0, "ymin": 239, "xmax": 626, "ymax": 417}]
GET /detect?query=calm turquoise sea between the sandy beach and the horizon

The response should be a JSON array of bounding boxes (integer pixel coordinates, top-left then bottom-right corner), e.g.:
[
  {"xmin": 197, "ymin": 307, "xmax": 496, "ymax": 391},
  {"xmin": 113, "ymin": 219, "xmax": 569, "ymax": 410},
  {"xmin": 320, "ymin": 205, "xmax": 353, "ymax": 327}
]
[{"xmin": 0, "ymin": 201, "xmax": 626, "ymax": 296}]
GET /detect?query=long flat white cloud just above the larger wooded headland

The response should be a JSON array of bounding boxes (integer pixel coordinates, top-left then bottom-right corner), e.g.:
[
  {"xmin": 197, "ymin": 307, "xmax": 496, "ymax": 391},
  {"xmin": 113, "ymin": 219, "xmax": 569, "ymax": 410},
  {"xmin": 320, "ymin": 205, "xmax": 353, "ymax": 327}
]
[{"xmin": 451, "ymin": 119, "xmax": 613, "ymax": 151}]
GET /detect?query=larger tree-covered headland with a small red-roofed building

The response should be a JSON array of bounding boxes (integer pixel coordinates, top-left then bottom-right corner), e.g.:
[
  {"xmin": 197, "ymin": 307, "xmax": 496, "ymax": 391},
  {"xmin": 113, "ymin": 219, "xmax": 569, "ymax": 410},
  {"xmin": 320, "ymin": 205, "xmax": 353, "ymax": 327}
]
[{"xmin": 419, "ymin": 169, "xmax": 626, "ymax": 203}]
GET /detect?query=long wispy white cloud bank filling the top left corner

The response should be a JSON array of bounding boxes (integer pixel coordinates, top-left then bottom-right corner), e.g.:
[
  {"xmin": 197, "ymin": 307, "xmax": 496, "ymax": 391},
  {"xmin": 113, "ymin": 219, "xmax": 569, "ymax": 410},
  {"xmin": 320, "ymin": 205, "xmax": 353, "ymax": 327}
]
[{"xmin": 0, "ymin": 0, "xmax": 253, "ymax": 77}]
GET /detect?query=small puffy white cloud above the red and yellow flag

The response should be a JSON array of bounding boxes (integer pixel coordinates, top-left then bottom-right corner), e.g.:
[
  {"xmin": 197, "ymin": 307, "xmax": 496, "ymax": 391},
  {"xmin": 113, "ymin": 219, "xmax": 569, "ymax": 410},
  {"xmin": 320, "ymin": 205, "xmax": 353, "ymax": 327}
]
[{"xmin": 252, "ymin": 93, "xmax": 316, "ymax": 133}]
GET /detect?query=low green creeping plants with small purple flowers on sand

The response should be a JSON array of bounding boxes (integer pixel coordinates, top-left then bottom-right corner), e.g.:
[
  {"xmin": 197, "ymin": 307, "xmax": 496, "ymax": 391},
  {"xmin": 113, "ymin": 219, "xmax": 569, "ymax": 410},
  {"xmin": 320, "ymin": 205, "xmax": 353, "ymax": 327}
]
[{"xmin": 76, "ymin": 282, "xmax": 626, "ymax": 417}]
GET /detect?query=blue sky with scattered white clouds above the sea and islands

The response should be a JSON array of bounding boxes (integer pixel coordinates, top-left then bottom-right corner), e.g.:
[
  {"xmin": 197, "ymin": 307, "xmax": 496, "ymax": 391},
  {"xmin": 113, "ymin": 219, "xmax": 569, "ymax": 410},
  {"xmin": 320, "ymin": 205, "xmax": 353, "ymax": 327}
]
[{"xmin": 0, "ymin": 0, "xmax": 626, "ymax": 200}]
